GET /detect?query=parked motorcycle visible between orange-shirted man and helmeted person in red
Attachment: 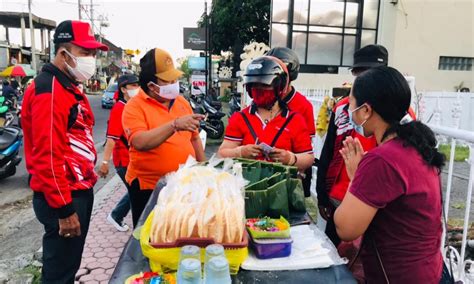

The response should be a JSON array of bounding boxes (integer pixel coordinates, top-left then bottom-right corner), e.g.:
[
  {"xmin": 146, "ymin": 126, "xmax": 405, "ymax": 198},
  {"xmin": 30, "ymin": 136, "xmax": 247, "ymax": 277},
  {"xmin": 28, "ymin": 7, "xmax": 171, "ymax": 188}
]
[{"xmin": 189, "ymin": 87, "xmax": 225, "ymax": 139}]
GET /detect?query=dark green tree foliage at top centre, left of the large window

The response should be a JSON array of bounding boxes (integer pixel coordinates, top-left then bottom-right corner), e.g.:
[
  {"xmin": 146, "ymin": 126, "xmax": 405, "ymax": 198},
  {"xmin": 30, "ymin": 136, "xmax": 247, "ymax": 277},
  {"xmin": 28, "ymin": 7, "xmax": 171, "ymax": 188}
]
[{"xmin": 198, "ymin": 0, "xmax": 271, "ymax": 54}]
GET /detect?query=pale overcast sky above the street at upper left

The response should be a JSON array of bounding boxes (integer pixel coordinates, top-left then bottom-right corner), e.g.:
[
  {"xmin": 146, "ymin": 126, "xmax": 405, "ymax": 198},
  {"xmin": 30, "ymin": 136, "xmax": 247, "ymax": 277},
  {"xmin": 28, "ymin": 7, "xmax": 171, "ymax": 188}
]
[{"xmin": 0, "ymin": 0, "xmax": 211, "ymax": 59}]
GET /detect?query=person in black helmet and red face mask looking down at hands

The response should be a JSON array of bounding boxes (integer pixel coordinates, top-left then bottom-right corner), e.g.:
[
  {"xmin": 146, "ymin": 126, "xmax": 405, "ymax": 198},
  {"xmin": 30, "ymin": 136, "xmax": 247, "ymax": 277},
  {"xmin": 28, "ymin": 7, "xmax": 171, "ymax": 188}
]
[{"xmin": 218, "ymin": 56, "xmax": 314, "ymax": 171}]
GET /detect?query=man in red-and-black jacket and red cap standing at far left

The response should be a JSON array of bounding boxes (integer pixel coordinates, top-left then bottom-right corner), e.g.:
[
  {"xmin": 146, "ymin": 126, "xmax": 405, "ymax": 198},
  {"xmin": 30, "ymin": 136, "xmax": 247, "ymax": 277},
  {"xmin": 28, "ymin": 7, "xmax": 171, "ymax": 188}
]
[{"xmin": 22, "ymin": 21, "xmax": 108, "ymax": 283}]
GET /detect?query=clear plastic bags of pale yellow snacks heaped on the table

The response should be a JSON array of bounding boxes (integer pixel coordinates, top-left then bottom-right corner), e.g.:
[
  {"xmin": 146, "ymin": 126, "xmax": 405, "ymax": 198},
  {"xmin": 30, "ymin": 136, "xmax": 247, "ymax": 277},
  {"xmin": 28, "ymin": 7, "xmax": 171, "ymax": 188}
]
[{"xmin": 150, "ymin": 155, "xmax": 246, "ymax": 243}]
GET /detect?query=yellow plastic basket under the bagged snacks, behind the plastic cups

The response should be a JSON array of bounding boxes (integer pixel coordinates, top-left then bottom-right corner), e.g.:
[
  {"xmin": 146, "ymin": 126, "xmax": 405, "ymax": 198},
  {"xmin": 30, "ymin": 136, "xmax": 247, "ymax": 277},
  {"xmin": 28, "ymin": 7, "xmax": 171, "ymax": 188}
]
[{"xmin": 140, "ymin": 210, "xmax": 248, "ymax": 275}]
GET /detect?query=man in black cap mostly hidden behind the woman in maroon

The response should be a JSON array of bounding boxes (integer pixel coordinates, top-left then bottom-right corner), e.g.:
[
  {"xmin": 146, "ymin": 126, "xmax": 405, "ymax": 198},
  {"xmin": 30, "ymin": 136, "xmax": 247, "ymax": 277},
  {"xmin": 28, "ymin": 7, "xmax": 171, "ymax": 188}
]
[{"xmin": 316, "ymin": 44, "xmax": 388, "ymax": 246}]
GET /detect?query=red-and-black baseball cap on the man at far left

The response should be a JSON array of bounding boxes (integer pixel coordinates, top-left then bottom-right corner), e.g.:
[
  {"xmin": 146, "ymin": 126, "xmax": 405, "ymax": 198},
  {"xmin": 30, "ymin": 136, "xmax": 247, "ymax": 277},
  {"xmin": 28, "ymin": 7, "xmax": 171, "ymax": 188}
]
[{"xmin": 53, "ymin": 20, "xmax": 109, "ymax": 51}]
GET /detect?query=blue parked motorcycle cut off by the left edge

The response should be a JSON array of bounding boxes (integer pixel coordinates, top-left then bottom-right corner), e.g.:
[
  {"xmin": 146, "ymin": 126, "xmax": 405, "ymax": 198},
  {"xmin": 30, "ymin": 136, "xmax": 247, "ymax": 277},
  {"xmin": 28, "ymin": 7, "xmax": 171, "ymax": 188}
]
[{"xmin": 0, "ymin": 126, "xmax": 23, "ymax": 179}]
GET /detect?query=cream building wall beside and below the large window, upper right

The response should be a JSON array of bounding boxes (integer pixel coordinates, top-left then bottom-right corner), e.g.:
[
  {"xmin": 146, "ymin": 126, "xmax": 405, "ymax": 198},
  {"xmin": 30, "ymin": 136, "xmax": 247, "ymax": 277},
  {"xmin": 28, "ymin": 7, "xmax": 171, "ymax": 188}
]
[{"xmin": 294, "ymin": 0, "xmax": 474, "ymax": 91}]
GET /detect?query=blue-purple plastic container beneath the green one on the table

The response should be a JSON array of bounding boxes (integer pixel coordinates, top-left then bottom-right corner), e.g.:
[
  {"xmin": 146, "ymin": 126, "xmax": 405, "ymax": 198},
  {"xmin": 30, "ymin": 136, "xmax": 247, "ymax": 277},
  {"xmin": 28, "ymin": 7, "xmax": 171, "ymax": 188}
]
[{"xmin": 250, "ymin": 238, "xmax": 293, "ymax": 259}]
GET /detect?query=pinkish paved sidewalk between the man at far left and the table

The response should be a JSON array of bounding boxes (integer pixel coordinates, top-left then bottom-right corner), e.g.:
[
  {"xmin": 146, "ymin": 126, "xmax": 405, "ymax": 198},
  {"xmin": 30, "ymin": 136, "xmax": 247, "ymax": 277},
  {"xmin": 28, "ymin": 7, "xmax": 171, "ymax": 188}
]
[{"xmin": 76, "ymin": 175, "xmax": 132, "ymax": 283}]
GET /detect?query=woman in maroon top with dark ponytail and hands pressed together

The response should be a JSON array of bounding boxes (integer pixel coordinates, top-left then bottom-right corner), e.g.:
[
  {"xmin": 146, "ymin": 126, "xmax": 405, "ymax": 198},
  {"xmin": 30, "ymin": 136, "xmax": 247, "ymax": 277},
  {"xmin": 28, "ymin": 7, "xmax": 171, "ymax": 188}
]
[{"xmin": 334, "ymin": 67, "xmax": 445, "ymax": 284}]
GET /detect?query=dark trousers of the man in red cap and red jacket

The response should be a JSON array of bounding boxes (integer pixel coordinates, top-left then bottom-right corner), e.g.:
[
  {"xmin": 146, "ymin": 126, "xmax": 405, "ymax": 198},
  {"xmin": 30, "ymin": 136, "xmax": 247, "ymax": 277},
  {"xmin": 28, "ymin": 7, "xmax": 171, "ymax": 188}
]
[{"xmin": 33, "ymin": 189, "xmax": 94, "ymax": 284}]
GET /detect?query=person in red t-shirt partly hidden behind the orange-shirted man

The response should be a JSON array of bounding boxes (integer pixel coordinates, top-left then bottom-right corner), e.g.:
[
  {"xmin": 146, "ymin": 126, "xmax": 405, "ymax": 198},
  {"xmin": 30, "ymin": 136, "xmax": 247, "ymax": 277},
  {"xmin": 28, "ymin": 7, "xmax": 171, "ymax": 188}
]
[{"xmin": 98, "ymin": 74, "xmax": 139, "ymax": 232}]
